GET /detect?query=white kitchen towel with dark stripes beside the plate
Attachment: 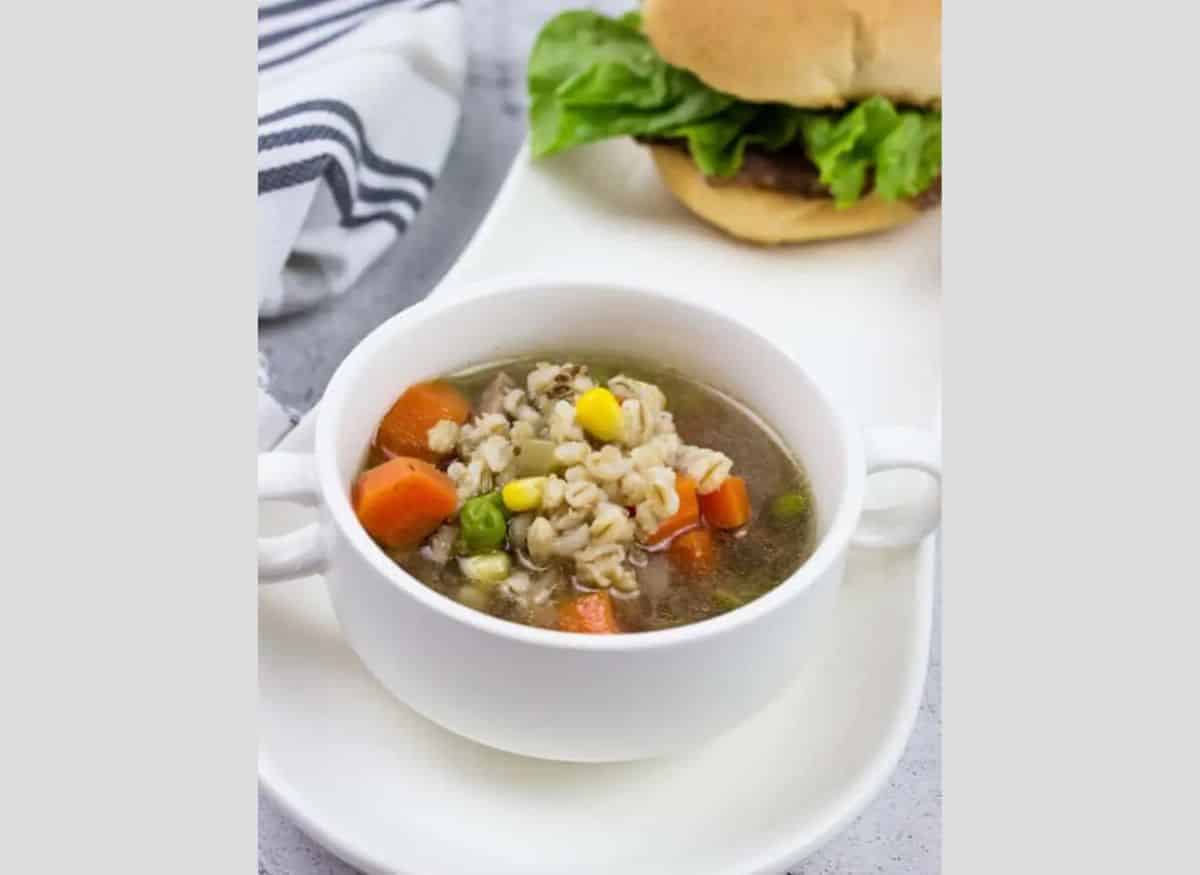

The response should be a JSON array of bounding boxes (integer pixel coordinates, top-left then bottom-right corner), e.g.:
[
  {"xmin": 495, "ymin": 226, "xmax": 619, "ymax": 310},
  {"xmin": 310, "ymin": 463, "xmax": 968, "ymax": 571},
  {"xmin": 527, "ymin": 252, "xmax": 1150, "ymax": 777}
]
[{"xmin": 258, "ymin": 0, "xmax": 466, "ymax": 447}]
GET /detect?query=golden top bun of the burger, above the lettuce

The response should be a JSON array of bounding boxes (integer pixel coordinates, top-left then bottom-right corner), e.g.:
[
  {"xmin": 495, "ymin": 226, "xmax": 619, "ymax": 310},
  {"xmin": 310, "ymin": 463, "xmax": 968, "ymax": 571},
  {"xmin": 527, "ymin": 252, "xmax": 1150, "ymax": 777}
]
[{"xmin": 642, "ymin": 0, "xmax": 942, "ymax": 108}]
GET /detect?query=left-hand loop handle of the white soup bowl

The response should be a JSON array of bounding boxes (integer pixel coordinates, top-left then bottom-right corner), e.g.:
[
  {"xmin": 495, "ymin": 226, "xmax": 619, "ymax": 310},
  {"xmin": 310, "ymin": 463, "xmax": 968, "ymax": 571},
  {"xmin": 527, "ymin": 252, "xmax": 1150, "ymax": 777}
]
[{"xmin": 258, "ymin": 453, "xmax": 328, "ymax": 583}]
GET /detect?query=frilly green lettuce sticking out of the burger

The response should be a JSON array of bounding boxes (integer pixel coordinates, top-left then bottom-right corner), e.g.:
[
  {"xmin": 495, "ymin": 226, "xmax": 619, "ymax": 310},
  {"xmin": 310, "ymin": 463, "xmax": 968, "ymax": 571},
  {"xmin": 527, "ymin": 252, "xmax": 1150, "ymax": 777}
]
[{"xmin": 528, "ymin": 11, "xmax": 942, "ymax": 206}]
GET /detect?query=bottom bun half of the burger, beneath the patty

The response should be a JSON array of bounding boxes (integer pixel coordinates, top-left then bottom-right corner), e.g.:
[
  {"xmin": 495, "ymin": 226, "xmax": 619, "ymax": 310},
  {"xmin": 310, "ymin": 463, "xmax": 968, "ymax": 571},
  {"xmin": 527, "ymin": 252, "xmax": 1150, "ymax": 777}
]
[{"xmin": 650, "ymin": 145, "xmax": 920, "ymax": 244}]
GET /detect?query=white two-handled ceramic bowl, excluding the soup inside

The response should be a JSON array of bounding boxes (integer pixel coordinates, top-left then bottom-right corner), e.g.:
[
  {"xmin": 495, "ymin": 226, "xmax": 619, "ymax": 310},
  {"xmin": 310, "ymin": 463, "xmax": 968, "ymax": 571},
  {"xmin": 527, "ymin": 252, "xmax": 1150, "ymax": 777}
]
[{"xmin": 258, "ymin": 274, "xmax": 941, "ymax": 762}]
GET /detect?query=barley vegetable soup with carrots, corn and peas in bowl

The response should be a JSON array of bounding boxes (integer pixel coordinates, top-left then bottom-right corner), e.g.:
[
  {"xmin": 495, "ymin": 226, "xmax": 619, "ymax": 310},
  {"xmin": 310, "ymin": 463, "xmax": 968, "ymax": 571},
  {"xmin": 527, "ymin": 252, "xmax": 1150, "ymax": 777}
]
[{"xmin": 353, "ymin": 356, "xmax": 816, "ymax": 633}]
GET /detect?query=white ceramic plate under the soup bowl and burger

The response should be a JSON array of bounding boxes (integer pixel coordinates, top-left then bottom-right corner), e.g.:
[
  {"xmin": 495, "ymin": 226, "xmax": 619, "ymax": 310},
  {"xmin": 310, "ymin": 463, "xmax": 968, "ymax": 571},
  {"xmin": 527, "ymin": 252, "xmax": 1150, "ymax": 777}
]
[{"xmin": 259, "ymin": 143, "xmax": 940, "ymax": 875}]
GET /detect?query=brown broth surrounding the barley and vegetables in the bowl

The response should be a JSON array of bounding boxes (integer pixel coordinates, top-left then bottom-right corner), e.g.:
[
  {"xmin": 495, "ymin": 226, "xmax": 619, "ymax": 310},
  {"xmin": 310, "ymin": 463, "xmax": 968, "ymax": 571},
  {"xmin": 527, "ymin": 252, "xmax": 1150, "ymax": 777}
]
[{"xmin": 355, "ymin": 354, "xmax": 816, "ymax": 633}]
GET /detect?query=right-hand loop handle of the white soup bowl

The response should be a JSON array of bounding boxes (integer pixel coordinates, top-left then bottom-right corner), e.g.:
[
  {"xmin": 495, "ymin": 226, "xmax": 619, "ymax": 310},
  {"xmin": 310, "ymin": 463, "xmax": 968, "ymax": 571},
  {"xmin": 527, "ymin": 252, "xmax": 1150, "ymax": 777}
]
[{"xmin": 851, "ymin": 427, "xmax": 942, "ymax": 547}]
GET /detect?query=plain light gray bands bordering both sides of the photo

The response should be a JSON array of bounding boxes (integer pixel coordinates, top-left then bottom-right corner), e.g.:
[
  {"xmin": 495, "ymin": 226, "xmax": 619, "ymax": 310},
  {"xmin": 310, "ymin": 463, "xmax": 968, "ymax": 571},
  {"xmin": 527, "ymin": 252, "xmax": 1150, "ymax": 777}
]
[{"xmin": 0, "ymin": 2, "xmax": 1200, "ymax": 875}]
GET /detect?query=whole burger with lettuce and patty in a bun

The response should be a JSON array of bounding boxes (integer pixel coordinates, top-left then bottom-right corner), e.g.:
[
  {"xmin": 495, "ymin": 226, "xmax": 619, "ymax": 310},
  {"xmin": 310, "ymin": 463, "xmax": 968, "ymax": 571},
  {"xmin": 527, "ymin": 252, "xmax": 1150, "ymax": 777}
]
[{"xmin": 528, "ymin": 0, "xmax": 942, "ymax": 244}]
